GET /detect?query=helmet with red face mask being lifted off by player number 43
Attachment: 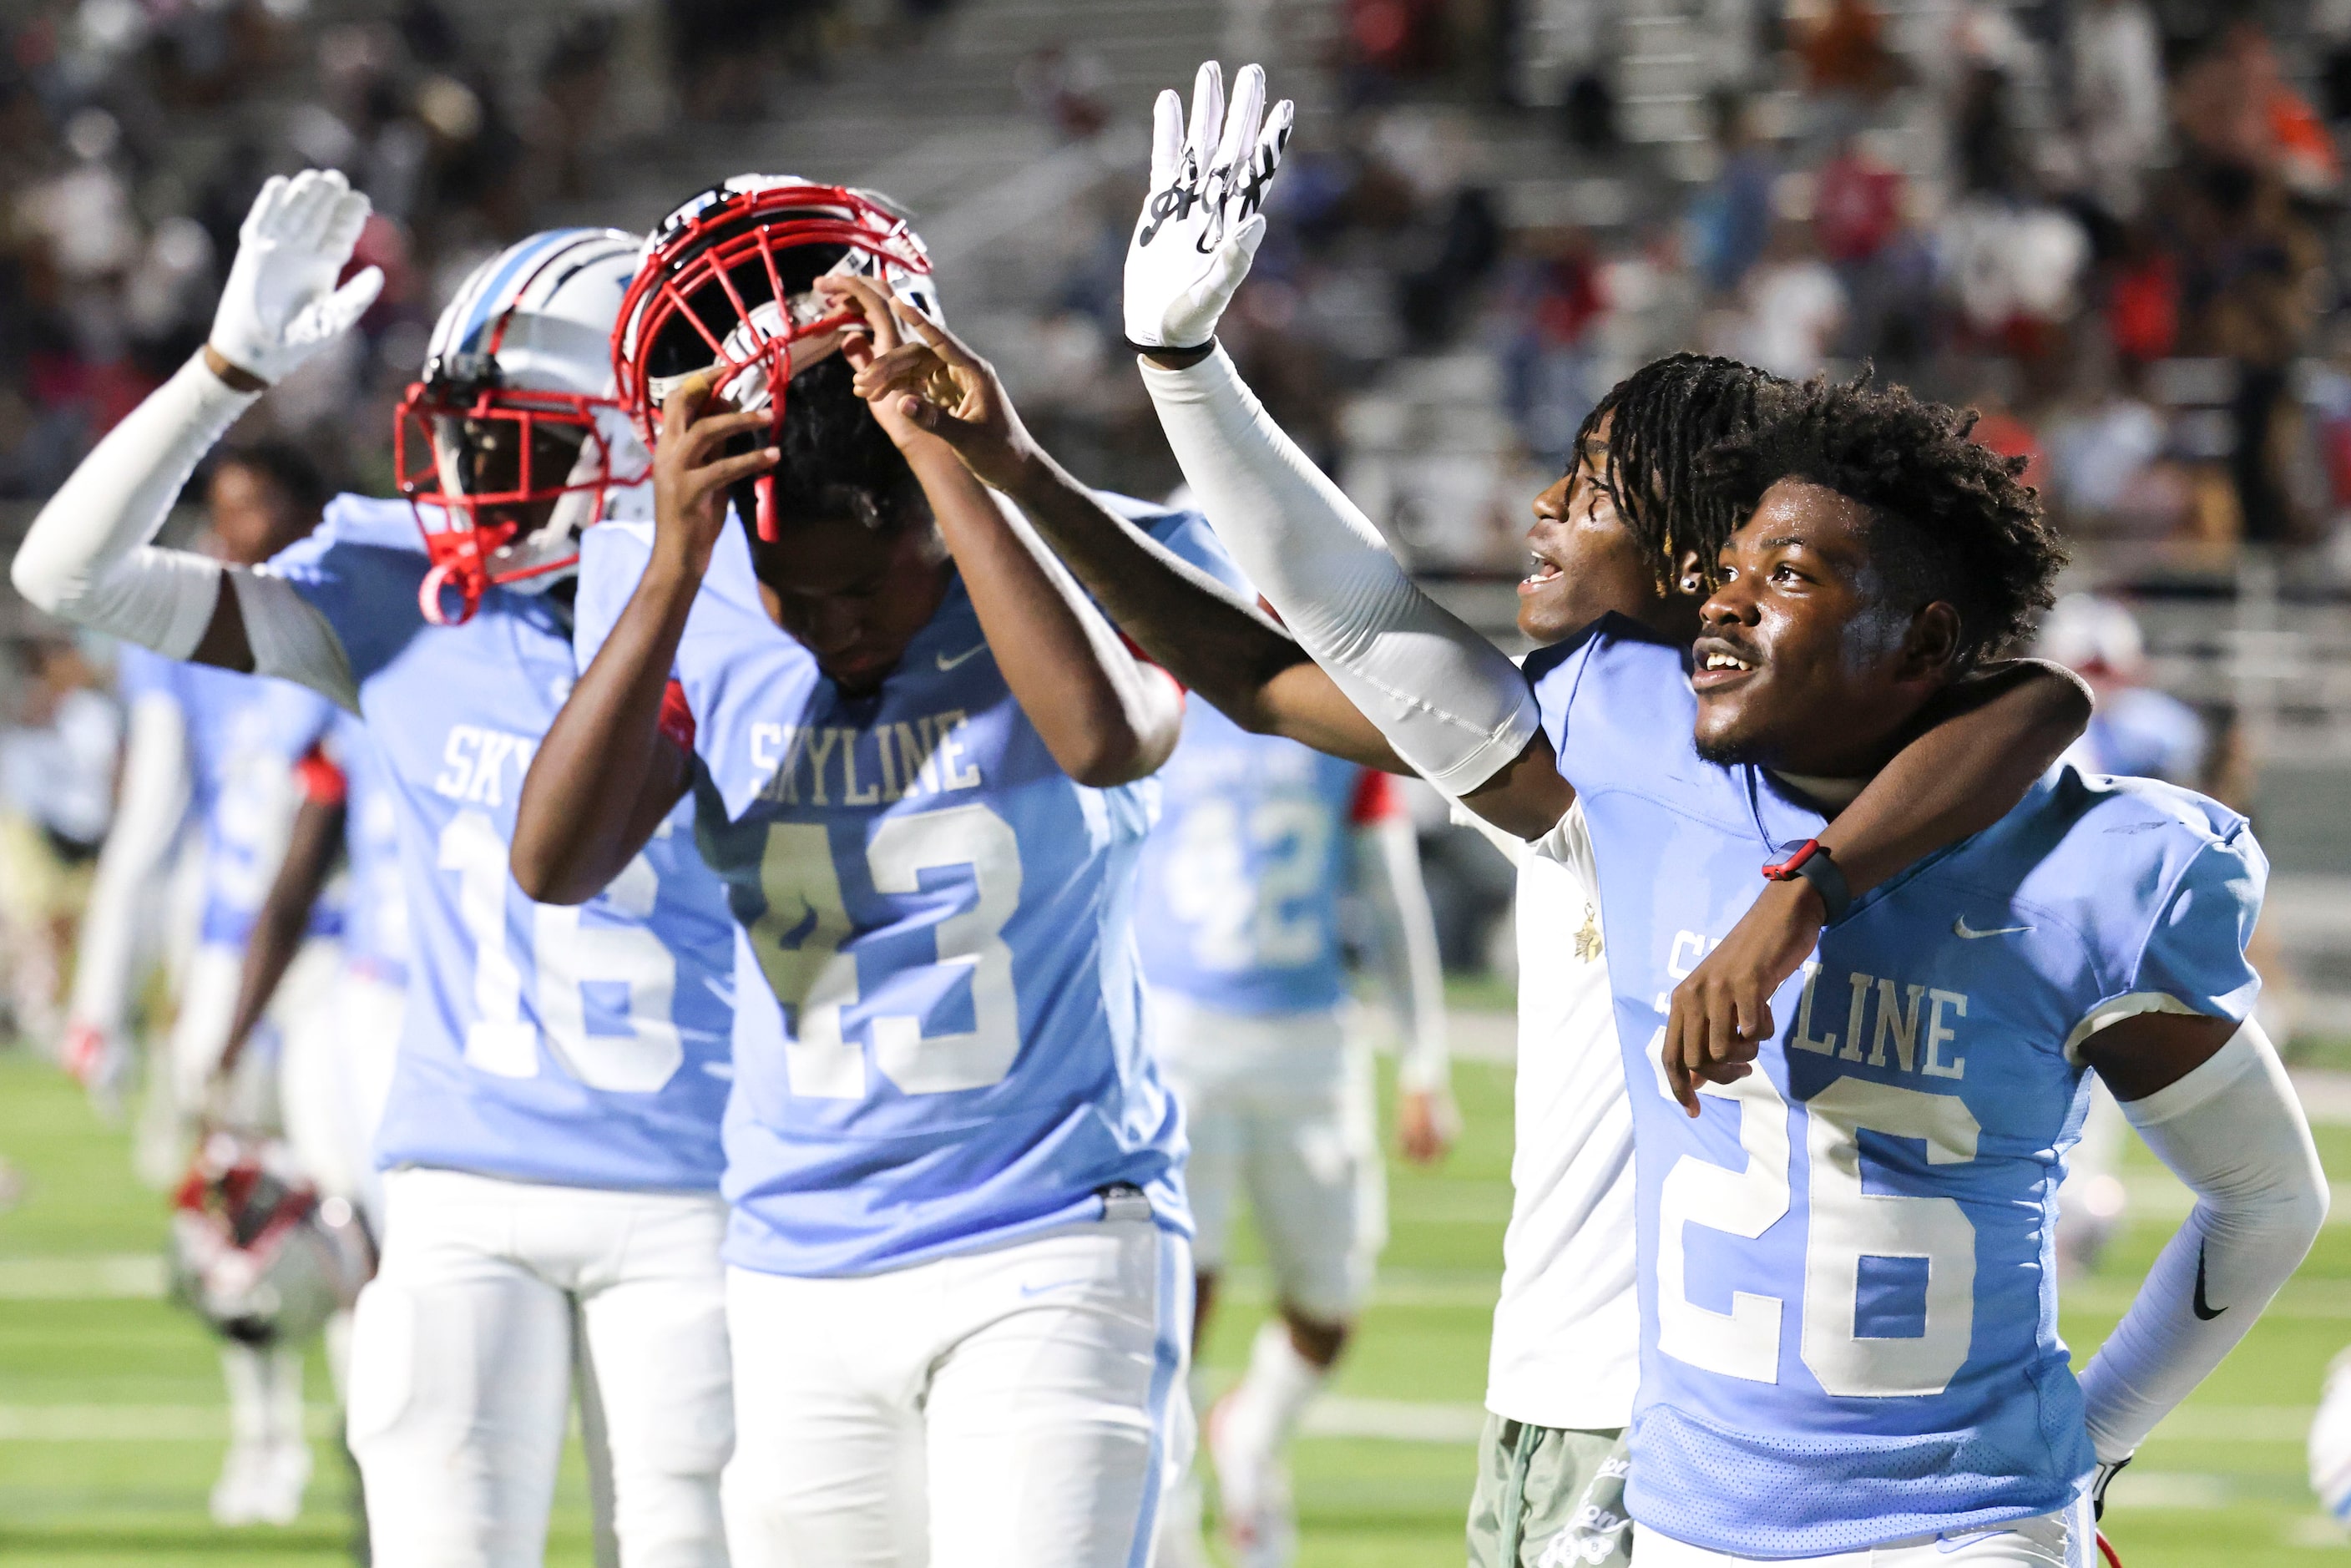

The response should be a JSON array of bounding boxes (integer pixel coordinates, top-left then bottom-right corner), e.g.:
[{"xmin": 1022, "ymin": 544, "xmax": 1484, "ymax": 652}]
[{"xmin": 611, "ymin": 174, "xmax": 938, "ymax": 539}]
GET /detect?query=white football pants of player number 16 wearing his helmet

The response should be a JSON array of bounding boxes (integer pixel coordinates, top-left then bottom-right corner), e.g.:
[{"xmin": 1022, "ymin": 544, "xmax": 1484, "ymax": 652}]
[{"xmin": 351, "ymin": 1168, "xmax": 734, "ymax": 1568}]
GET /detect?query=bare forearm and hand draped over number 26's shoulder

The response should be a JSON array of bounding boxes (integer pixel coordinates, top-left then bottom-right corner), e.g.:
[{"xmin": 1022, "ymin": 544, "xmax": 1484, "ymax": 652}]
[{"xmin": 1657, "ymin": 658, "xmax": 2090, "ymax": 1116}]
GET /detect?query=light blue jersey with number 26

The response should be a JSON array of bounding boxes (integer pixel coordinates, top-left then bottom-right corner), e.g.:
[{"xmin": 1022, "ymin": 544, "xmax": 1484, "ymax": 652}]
[{"xmin": 1528, "ymin": 619, "xmax": 2267, "ymax": 1559}]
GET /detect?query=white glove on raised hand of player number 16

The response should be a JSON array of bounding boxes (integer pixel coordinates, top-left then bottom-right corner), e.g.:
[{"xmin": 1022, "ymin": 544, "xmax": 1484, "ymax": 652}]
[{"xmin": 210, "ymin": 169, "xmax": 383, "ymax": 381}]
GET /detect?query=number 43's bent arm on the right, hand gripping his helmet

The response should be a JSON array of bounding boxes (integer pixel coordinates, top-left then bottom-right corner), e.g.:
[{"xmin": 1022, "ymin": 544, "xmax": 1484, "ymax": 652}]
[{"xmin": 818, "ymin": 277, "xmax": 1182, "ymax": 787}]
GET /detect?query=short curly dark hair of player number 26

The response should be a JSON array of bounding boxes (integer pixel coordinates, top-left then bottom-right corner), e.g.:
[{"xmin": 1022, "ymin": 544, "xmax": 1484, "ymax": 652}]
[{"xmin": 1706, "ymin": 369, "xmax": 2066, "ymax": 665}]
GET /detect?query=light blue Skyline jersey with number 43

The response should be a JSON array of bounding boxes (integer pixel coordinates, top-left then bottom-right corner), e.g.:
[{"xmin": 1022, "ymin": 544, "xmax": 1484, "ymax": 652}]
[{"xmin": 579, "ymin": 503, "xmax": 1230, "ymax": 1277}]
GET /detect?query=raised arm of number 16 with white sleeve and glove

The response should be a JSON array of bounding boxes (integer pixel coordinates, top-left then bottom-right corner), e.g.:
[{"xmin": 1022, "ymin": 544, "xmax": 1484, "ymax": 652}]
[{"xmin": 9, "ymin": 169, "xmax": 383, "ymax": 706}]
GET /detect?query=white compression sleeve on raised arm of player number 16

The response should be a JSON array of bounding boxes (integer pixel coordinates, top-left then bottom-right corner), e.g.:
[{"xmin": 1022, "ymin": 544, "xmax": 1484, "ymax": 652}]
[{"xmin": 9, "ymin": 355, "xmax": 259, "ymax": 658}]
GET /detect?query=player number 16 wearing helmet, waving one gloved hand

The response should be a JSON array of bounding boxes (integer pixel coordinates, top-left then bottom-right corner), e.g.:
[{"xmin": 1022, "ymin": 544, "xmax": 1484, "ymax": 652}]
[{"xmin": 12, "ymin": 172, "xmax": 734, "ymax": 1565}]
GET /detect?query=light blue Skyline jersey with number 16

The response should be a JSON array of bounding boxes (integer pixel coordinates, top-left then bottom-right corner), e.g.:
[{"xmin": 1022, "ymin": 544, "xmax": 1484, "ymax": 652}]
[{"xmin": 268, "ymin": 496, "xmax": 734, "ymax": 1190}]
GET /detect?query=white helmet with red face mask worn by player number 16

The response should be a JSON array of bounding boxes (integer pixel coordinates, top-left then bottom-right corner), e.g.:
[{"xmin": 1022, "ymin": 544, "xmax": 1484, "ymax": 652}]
[{"xmin": 392, "ymin": 228, "xmax": 654, "ymax": 623}]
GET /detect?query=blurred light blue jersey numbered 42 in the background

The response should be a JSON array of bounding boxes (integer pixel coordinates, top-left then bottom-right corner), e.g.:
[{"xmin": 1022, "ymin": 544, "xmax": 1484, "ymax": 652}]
[{"xmin": 1135, "ymin": 703, "xmax": 1387, "ymax": 1015}]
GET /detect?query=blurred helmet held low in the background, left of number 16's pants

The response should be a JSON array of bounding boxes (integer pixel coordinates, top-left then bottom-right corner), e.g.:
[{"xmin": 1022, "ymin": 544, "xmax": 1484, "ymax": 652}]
[{"xmin": 169, "ymin": 1133, "xmax": 377, "ymax": 1345}]
